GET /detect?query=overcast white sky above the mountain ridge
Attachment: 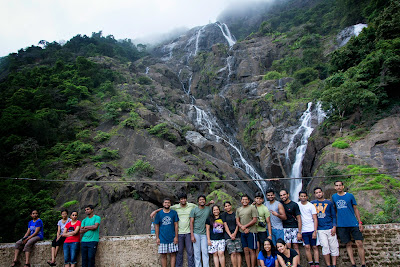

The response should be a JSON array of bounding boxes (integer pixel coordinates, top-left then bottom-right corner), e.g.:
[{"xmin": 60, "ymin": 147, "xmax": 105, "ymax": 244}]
[{"xmin": 0, "ymin": 0, "xmax": 266, "ymax": 57}]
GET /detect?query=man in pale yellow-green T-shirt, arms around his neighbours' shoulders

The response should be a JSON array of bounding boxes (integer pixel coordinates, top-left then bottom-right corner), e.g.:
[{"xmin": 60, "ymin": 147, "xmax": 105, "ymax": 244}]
[{"xmin": 150, "ymin": 193, "xmax": 198, "ymax": 267}]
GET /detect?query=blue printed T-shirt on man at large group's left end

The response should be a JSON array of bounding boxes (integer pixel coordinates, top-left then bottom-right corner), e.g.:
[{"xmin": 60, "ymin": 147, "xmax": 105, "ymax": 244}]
[{"xmin": 154, "ymin": 210, "xmax": 179, "ymax": 244}]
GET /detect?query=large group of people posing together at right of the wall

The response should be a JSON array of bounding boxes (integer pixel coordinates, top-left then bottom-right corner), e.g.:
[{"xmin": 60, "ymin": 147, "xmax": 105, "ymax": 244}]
[{"xmin": 150, "ymin": 181, "xmax": 366, "ymax": 267}]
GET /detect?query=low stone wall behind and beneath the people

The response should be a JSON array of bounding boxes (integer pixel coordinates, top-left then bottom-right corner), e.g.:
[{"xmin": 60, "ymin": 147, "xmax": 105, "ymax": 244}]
[{"xmin": 0, "ymin": 224, "xmax": 400, "ymax": 267}]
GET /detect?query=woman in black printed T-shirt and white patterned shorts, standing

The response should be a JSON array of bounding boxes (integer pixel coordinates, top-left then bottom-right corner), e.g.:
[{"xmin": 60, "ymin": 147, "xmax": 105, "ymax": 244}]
[{"xmin": 206, "ymin": 205, "xmax": 225, "ymax": 267}]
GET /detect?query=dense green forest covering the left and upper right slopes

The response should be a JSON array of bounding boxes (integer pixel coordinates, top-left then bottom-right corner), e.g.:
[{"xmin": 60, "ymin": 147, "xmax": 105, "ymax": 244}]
[{"xmin": 0, "ymin": 0, "xmax": 400, "ymax": 242}]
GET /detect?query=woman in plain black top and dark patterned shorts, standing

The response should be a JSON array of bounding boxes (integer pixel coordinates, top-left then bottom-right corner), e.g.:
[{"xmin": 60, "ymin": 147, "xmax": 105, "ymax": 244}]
[{"xmin": 221, "ymin": 201, "xmax": 243, "ymax": 267}]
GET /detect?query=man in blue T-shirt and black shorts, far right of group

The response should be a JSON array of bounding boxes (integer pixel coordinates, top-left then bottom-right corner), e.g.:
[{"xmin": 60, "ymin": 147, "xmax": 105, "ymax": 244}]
[{"xmin": 332, "ymin": 181, "xmax": 365, "ymax": 267}]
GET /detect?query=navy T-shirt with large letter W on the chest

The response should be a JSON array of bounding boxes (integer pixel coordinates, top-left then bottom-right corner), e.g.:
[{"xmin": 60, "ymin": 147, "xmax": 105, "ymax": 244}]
[{"xmin": 311, "ymin": 199, "xmax": 336, "ymax": 230}]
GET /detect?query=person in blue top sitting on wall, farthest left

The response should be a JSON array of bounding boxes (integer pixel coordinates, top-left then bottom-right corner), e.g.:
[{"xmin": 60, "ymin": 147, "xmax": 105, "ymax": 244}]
[{"xmin": 11, "ymin": 210, "xmax": 43, "ymax": 267}]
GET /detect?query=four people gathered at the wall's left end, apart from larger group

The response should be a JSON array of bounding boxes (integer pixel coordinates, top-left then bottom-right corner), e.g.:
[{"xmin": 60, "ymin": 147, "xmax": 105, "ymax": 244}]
[{"xmin": 11, "ymin": 205, "xmax": 101, "ymax": 267}]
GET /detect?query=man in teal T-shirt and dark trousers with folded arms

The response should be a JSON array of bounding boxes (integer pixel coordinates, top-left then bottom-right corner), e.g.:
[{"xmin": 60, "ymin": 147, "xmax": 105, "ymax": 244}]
[{"xmin": 80, "ymin": 205, "xmax": 101, "ymax": 267}]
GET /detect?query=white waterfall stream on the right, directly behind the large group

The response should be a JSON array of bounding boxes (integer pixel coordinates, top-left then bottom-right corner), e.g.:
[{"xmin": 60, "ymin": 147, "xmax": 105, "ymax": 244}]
[{"xmin": 285, "ymin": 102, "xmax": 326, "ymax": 201}]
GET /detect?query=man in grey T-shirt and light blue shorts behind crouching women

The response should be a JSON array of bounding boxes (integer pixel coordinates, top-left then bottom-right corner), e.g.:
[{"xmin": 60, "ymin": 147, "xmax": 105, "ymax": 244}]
[{"xmin": 265, "ymin": 189, "xmax": 286, "ymax": 245}]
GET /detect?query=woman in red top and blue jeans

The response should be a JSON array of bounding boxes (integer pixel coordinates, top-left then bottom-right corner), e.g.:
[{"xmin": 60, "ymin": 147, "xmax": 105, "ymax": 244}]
[{"xmin": 62, "ymin": 211, "xmax": 81, "ymax": 267}]
